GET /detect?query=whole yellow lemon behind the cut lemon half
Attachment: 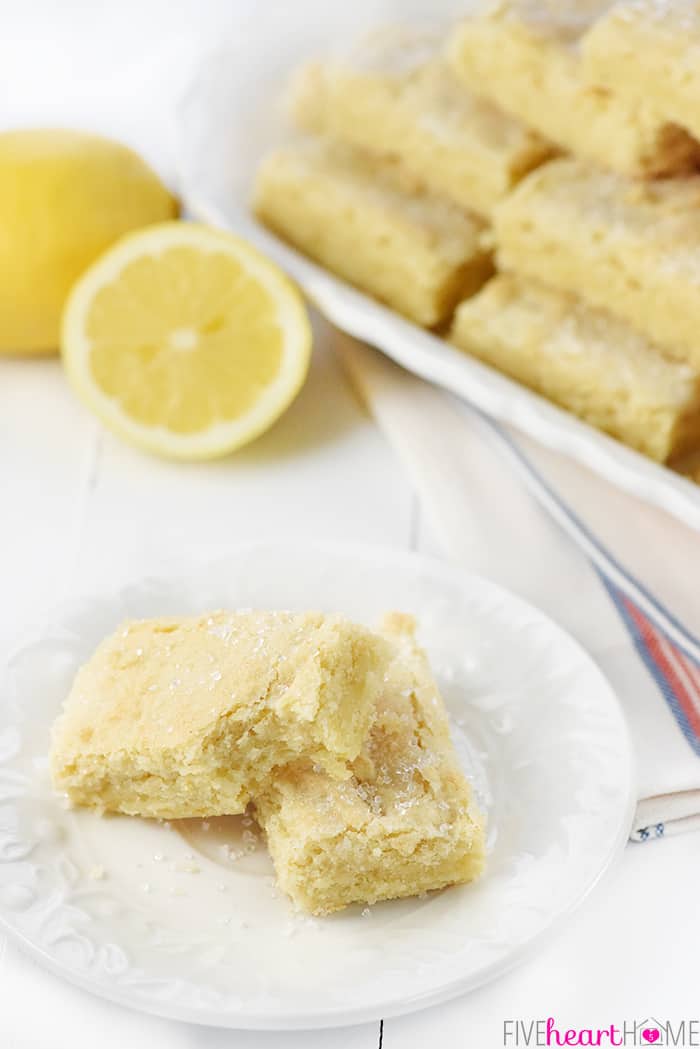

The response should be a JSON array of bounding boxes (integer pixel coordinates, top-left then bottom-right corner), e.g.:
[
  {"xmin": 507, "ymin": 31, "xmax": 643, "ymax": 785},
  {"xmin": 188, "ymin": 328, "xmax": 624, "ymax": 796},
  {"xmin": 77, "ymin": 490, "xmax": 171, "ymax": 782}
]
[{"xmin": 0, "ymin": 129, "xmax": 178, "ymax": 354}]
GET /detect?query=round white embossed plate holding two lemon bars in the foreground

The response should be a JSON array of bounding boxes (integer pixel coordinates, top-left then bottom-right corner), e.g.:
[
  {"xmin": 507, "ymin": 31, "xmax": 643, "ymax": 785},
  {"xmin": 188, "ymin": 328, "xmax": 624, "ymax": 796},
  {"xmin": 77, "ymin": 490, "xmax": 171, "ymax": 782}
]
[{"xmin": 0, "ymin": 545, "xmax": 633, "ymax": 1029}]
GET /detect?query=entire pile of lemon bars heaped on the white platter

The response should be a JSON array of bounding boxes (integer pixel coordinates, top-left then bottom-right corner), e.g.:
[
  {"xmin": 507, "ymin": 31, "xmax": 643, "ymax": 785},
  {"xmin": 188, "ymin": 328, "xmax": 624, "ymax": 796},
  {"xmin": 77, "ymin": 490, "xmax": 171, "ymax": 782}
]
[{"xmin": 254, "ymin": 0, "xmax": 700, "ymax": 463}]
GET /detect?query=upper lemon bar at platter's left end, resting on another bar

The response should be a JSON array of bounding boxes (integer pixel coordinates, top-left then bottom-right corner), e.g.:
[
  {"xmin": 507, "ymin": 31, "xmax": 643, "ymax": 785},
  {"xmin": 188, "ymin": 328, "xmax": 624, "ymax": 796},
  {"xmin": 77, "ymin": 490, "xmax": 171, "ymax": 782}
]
[{"xmin": 292, "ymin": 30, "xmax": 552, "ymax": 216}]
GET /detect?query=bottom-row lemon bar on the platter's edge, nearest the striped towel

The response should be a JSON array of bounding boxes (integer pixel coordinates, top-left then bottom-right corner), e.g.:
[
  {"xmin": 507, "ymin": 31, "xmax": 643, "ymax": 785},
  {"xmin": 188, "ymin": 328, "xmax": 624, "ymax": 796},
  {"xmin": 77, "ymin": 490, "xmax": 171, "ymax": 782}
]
[{"xmin": 451, "ymin": 274, "xmax": 700, "ymax": 463}]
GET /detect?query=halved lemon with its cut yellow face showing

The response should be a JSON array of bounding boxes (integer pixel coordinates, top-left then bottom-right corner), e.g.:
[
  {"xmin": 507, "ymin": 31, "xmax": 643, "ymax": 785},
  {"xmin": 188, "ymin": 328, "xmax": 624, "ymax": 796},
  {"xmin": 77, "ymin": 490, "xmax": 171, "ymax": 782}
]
[{"xmin": 61, "ymin": 222, "xmax": 312, "ymax": 459}]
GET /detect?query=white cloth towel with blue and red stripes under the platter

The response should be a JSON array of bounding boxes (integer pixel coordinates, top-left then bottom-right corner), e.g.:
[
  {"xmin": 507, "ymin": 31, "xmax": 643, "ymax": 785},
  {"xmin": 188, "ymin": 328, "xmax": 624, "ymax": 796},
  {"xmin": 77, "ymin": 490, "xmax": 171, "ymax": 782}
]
[{"xmin": 337, "ymin": 335, "xmax": 700, "ymax": 841}]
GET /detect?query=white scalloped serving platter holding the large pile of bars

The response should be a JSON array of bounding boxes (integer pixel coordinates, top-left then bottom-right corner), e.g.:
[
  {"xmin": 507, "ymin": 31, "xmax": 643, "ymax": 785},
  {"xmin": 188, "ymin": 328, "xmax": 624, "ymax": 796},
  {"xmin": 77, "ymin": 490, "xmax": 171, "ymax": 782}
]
[{"xmin": 172, "ymin": 18, "xmax": 700, "ymax": 530}]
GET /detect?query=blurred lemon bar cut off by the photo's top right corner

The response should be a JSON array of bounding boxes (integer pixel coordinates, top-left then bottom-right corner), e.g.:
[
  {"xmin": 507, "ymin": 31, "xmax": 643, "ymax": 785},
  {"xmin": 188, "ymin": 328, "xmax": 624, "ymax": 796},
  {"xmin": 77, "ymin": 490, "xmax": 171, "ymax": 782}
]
[{"xmin": 582, "ymin": 0, "xmax": 700, "ymax": 144}]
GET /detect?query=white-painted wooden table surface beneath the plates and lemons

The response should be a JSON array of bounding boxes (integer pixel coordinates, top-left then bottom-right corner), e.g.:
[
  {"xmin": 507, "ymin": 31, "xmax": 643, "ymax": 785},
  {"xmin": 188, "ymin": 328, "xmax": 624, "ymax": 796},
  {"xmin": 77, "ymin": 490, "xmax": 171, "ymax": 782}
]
[{"xmin": 0, "ymin": 0, "xmax": 700, "ymax": 1049}]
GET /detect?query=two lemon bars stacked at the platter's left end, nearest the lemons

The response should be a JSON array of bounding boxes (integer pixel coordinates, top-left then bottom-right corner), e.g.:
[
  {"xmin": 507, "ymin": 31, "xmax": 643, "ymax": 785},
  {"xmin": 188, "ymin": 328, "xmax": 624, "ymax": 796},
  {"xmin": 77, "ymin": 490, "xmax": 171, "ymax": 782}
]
[{"xmin": 255, "ymin": 29, "xmax": 552, "ymax": 327}]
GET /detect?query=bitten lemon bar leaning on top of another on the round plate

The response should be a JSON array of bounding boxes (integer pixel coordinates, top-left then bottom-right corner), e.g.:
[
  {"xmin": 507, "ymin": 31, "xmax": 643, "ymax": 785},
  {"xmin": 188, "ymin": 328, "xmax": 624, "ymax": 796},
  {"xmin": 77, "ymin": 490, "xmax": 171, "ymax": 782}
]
[{"xmin": 51, "ymin": 612, "xmax": 385, "ymax": 818}]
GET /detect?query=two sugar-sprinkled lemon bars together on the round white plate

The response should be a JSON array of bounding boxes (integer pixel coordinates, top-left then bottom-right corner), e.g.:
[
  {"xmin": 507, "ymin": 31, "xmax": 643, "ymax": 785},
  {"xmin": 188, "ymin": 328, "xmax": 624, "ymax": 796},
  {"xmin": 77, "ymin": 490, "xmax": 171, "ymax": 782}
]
[{"xmin": 51, "ymin": 612, "xmax": 485, "ymax": 914}]
